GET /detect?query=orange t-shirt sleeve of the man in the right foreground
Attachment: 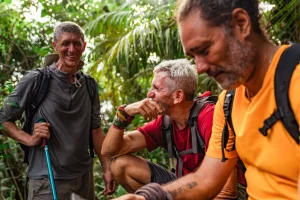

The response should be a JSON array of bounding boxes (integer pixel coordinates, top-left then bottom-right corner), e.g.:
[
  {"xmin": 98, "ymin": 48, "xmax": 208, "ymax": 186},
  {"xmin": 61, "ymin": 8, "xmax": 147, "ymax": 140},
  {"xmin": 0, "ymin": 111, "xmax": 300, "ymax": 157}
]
[{"xmin": 206, "ymin": 91, "xmax": 238, "ymax": 159}]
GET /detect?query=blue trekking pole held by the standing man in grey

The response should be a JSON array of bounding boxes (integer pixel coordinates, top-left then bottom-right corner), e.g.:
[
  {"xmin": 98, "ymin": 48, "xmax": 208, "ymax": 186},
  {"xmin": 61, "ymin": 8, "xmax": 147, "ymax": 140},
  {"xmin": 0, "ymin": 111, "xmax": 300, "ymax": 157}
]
[{"xmin": 36, "ymin": 118, "xmax": 58, "ymax": 200}]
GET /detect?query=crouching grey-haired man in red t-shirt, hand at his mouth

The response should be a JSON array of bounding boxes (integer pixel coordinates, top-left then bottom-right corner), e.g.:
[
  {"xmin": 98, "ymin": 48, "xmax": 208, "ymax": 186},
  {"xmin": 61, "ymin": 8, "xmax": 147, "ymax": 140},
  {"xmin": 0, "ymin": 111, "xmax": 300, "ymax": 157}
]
[{"xmin": 102, "ymin": 59, "xmax": 244, "ymax": 199}]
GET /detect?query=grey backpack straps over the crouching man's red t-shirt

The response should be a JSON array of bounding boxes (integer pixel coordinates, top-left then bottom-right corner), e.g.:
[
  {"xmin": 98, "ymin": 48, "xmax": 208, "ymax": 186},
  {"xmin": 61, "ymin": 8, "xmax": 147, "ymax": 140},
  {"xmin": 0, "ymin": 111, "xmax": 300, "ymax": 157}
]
[{"xmin": 162, "ymin": 96, "xmax": 218, "ymax": 177}]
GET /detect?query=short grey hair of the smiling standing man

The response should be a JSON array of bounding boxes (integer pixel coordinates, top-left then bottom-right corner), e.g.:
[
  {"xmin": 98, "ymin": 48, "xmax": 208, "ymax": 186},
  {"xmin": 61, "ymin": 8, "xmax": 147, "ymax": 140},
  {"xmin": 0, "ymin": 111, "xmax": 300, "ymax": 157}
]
[{"xmin": 53, "ymin": 22, "xmax": 84, "ymax": 42}]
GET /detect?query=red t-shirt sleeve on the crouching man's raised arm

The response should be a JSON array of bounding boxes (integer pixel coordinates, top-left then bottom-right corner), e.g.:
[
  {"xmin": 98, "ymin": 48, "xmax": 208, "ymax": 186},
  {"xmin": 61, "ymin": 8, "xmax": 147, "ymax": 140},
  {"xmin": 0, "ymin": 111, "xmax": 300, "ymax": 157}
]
[{"xmin": 138, "ymin": 115, "xmax": 164, "ymax": 151}]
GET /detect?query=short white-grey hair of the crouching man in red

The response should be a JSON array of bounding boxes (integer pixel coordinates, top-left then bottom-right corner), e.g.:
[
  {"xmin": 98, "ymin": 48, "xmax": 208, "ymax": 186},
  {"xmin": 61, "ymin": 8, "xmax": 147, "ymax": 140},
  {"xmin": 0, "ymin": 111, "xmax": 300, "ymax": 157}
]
[{"xmin": 153, "ymin": 59, "xmax": 198, "ymax": 100}]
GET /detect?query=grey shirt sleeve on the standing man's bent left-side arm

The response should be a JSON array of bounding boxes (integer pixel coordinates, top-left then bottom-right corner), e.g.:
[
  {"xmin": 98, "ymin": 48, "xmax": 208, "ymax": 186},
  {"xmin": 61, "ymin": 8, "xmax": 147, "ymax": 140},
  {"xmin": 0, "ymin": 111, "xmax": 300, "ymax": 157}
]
[{"xmin": 0, "ymin": 70, "xmax": 40, "ymax": 124}]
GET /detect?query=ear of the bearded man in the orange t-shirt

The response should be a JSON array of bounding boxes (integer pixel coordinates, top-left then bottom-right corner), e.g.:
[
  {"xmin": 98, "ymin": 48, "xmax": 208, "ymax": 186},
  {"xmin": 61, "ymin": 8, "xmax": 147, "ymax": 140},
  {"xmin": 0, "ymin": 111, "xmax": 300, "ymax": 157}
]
[{"xmin": 231, "ymin": 8, "xmax": 252, "ymax": 42}]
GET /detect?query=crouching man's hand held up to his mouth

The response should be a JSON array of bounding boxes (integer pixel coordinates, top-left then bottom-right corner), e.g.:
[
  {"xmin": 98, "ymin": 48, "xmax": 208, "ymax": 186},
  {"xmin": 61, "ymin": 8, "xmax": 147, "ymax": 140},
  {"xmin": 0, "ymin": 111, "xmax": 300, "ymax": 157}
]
[{"xmin": 124, "ymin": 98, "xmax": 163, "ymax": 120}]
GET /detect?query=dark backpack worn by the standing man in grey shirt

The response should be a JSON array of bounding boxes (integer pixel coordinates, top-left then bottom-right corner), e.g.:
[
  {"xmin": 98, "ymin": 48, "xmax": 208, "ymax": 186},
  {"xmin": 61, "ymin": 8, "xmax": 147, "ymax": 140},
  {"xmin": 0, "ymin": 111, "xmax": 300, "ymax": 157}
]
[{"xmin": 20, "ymin": 66, "xmax": 98, "ymax": 163}]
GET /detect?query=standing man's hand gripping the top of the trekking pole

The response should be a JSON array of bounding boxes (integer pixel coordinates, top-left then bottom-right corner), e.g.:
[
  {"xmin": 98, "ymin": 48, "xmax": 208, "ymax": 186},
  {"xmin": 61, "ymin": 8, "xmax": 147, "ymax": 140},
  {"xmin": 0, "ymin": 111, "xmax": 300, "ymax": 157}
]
[{"xmin": 27, "ymin": 122, "xmax": 50, "ymax": 146}]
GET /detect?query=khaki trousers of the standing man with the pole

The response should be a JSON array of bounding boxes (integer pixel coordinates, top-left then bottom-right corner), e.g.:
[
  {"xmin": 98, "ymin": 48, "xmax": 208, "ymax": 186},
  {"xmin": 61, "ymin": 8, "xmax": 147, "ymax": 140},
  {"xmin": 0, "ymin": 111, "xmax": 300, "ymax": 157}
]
[{"xmin": 28, "ymin": 171, "xmax": 95, "ymax": 200}]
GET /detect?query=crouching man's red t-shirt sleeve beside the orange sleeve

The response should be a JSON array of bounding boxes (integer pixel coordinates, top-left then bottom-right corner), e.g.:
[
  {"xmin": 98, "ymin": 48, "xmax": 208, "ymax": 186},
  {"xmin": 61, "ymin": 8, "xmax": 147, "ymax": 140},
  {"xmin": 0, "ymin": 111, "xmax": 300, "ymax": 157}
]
[{"xmin": 198, "ymin": 103, "xmax": 215, "ymax": 151}]
